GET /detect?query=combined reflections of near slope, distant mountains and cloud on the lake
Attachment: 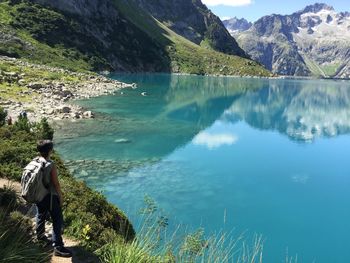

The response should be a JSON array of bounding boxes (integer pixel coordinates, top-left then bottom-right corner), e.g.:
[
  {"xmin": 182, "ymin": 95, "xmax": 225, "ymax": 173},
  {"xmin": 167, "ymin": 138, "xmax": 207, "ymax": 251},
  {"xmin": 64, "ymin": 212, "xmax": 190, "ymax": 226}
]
[{"xmin": 57, "ymin": 74, "xmax": 350, "ymax": 163}]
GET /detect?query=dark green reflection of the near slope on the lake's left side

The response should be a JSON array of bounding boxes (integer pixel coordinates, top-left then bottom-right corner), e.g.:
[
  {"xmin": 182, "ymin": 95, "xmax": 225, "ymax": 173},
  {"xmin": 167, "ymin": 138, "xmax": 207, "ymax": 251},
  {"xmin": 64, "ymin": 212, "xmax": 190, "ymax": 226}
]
[{"xmin": 56, "ymin": 74, "xmax": 267, "ymax": 160}]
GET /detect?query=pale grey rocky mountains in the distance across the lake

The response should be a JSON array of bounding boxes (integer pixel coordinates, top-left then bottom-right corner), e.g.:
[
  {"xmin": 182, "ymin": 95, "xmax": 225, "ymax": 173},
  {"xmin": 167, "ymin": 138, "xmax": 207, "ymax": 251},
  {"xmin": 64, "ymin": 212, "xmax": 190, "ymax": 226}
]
[{"xmin": 226, "ymin": 3, "xmax": 350, "ymax": 78}]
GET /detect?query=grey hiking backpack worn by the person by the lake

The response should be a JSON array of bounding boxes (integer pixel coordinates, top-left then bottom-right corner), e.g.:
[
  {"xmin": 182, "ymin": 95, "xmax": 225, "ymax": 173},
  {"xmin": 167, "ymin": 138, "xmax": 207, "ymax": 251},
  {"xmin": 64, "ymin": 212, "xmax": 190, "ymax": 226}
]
[{"xmin": 21, "ymin": 157, "xmax": 49, "ymax": 203}]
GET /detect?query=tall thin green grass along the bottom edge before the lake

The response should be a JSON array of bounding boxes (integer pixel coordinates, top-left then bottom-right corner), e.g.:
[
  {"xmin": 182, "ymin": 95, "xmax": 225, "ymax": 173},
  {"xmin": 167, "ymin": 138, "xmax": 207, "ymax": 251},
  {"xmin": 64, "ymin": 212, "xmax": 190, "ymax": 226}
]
[{"xmin": 98, "ymin": 197, "xmax": 263, "ymax": 263}]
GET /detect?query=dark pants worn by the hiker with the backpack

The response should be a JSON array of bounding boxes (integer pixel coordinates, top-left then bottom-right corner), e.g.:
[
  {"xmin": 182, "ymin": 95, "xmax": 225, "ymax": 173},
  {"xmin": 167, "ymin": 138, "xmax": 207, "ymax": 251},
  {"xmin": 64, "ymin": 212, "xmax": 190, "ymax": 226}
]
[{"xmin": 36, "ymin": 194, "xmax": 63, "ymax": 247}]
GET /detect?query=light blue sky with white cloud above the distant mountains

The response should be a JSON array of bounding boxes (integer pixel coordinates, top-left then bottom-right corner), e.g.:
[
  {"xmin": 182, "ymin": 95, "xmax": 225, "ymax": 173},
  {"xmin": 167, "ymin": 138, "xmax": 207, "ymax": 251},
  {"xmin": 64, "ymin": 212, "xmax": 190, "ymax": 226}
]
[{"xmin": 202, "ymin": 0, "xmax": 350, "ymax": 22}]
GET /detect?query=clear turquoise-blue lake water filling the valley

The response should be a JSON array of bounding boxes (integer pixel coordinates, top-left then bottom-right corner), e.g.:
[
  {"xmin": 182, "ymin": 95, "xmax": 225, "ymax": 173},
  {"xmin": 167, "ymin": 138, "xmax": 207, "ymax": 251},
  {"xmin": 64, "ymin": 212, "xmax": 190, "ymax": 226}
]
[{"xmin": 56, "ymin": 74, "xmax": 350, "ymax": 263}]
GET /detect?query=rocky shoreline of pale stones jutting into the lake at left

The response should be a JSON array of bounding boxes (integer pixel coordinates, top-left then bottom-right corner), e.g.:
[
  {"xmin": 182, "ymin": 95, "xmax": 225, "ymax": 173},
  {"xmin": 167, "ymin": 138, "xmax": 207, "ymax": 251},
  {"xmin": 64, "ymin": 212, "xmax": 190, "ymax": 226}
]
[{"xmin": 0, "ymin": 57, "xmax": 136, "ymax": 121}]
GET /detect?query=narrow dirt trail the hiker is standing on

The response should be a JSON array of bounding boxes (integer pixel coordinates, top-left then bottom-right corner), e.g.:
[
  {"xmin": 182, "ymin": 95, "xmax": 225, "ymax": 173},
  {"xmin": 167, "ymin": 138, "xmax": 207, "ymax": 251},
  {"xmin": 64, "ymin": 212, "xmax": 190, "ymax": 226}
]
[{"xmin": 0, "ymin": 178, "xmax": 100, "ymax": 263}]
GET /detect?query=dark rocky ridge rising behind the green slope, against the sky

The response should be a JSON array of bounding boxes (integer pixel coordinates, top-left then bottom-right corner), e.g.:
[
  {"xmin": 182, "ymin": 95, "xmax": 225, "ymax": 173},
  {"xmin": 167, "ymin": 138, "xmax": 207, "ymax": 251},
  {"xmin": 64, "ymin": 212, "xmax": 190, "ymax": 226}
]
[{"xmin": 134, "ymin": 0, "xmax": 246, "ymax": 57}]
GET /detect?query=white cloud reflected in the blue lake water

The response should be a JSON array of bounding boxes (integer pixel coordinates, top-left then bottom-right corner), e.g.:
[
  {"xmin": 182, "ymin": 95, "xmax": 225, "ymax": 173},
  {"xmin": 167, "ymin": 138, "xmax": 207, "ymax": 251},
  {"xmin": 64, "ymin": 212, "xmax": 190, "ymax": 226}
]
[{"xmin": 193, "ymin": 132, "xmax": 238, "ymax": 149}]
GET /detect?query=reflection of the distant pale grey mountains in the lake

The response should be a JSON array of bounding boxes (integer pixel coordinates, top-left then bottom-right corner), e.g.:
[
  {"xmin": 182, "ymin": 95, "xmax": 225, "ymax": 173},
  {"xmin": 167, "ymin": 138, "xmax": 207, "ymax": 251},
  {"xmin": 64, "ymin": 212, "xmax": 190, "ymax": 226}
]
[{"xmin": 223, "ymin": 81, "xmax": 350, "ymax": 142}]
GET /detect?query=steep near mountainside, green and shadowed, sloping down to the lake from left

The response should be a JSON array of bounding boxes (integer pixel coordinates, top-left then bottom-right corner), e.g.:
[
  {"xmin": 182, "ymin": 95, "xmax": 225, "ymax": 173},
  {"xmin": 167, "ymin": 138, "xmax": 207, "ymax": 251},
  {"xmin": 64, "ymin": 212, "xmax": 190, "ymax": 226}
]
[{"xmin": 0, "ymin": 0, "xmax": 270, "ymax": 76}]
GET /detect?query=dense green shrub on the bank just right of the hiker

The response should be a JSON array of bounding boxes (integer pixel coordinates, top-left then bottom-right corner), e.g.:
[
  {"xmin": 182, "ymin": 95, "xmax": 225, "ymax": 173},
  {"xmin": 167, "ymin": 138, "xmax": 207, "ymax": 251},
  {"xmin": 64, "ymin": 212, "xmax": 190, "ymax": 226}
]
[{"xmin": 58, "ymin": 176, "xmax": 135, "ymax": 250}]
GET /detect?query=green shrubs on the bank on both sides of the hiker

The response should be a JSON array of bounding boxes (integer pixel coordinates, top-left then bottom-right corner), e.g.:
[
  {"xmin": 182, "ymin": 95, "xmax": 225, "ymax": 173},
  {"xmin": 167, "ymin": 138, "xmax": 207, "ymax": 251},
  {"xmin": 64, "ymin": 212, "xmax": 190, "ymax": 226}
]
[{"xmin": 0, "ymin": 118, "xmax": 135, "ymax": 250}]
